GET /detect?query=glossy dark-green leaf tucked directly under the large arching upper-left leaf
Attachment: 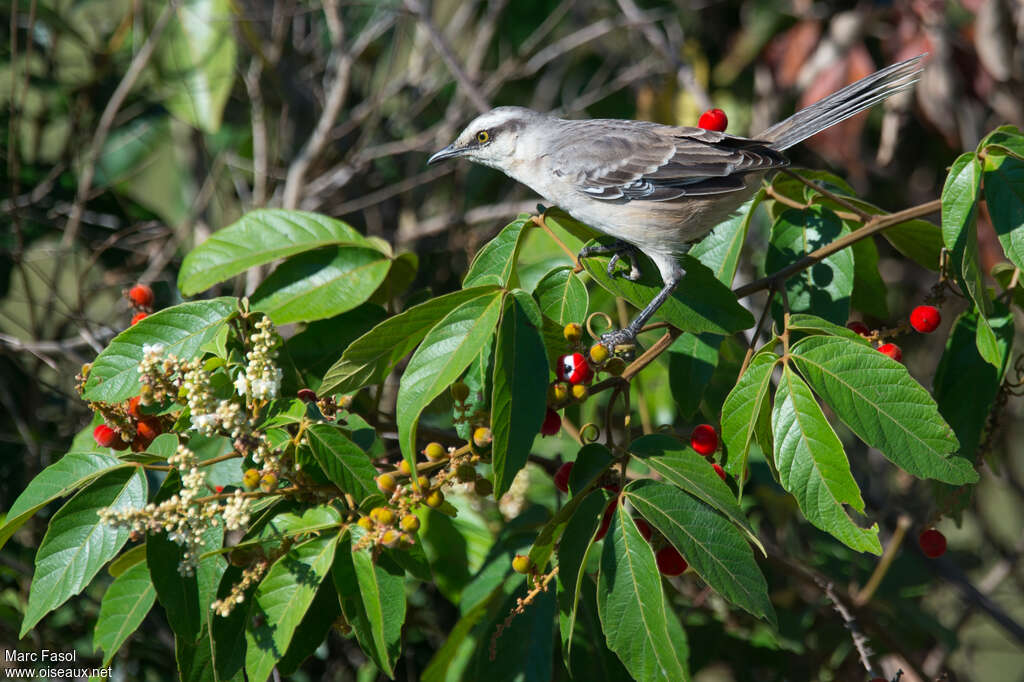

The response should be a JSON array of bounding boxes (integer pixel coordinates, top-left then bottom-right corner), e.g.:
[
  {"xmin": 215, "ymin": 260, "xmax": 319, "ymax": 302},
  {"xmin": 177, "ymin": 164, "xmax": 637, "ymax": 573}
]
[{"xmin": 252, "ymin": 247, "xmax": 391, "ymax": 325}]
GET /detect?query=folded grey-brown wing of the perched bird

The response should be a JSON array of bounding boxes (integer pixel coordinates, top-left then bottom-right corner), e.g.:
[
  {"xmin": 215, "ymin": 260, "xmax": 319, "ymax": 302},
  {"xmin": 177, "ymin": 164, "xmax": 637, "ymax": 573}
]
[{"xmin": 551, "ymin": 120, "xmax": 788, "ymax": 202}]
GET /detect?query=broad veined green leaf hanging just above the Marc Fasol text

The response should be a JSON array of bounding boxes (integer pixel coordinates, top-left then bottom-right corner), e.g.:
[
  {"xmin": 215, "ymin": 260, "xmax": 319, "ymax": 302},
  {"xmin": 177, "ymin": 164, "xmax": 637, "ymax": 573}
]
[{"xmin": 18, "ymin": 467, "xmax": 146, "ymax": 638}]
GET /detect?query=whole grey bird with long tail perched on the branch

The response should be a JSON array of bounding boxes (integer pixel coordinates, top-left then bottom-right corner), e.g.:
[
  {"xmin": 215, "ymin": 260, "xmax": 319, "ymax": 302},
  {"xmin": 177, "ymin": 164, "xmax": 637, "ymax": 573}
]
[{"xmin": 427, "ymin": 54, "xmax": 925, "ymax": 349}]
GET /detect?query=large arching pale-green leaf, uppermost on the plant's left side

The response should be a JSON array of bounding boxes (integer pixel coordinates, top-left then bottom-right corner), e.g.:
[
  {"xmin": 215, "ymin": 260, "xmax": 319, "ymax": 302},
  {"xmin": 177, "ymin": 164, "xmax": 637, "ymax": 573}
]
[{"xmin": 178, "ymin": 209, "xmax": 389, "ymax": 296}]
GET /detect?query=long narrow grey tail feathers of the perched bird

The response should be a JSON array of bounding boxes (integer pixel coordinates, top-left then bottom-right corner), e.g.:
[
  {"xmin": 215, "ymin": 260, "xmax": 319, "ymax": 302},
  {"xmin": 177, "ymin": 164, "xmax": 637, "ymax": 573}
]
[{"xmin": 756, "ymin": 54, "xmax": 925, "ymax": 152}]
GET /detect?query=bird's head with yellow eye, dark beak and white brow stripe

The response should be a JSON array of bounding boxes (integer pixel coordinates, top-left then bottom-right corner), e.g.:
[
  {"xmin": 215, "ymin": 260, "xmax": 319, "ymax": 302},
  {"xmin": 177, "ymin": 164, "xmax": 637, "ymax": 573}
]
[{"xmin": 427, "ymin": 106, "xmax": 544, "ymax": 171}]
